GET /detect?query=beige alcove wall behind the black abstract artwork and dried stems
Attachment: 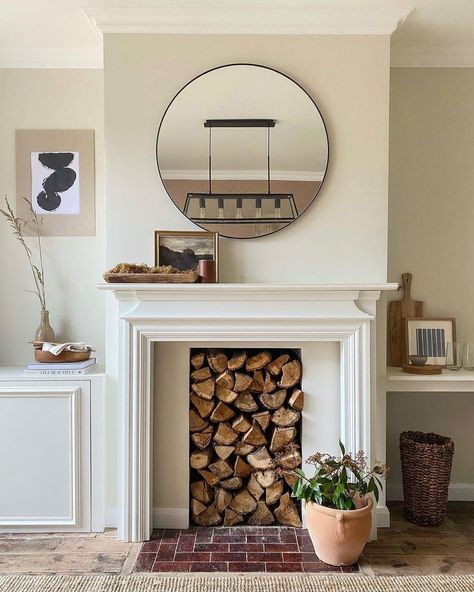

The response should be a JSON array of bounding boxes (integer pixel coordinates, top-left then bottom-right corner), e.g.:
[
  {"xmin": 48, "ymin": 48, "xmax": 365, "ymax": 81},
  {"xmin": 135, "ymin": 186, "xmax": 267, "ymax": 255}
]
[{"xmin": 0, "ymin": 70, "xmax": 105, "ymax": 364}]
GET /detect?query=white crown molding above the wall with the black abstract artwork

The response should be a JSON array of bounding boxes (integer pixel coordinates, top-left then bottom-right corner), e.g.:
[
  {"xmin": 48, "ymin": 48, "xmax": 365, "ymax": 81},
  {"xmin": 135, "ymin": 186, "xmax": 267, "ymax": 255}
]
[{"xmin": 0, "ymin": 44, "xmax": 103, "ymax": 69}]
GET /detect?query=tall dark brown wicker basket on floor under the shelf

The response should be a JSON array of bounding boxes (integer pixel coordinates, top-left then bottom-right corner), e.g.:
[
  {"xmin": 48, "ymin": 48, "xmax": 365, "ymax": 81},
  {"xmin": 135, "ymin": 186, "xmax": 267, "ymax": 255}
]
[{"xmin": 400, "ymin": 432, "xmax": 454, "ymax": 526}]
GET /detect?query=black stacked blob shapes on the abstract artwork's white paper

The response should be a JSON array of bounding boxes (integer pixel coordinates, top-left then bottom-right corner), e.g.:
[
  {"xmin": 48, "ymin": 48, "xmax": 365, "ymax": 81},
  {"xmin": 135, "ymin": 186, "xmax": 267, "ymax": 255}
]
[{"xmin": 36, "ymin": 152, "xmax": 77, "ymax": 212}]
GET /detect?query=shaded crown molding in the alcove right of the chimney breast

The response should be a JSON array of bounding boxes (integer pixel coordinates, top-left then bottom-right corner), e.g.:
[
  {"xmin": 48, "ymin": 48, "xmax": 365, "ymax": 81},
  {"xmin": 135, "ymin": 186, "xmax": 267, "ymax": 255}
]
[{"xmin": 391, "ymin": 45, "xmax": 474, "ymax": 68}]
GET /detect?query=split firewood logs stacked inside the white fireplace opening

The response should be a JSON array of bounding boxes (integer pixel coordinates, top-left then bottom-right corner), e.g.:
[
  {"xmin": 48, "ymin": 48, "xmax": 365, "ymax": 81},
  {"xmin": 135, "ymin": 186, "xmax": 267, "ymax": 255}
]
[{"xmin": 189, "ymin": 350, "xmax": 304, "ymax": 527}]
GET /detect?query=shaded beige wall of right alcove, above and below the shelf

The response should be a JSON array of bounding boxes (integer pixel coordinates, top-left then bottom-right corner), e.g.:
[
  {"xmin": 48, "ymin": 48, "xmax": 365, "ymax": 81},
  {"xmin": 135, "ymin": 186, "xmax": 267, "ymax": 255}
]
[{"xmin": 387, "ymin": 68, "xmax": 474, "ymax": 499}]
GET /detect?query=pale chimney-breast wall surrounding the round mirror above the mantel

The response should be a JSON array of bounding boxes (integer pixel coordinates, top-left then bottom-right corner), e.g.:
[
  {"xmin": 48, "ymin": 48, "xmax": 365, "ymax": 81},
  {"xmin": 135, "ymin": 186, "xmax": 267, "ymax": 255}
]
[{"xmin": 104, "ymin": 34, "xmax": 389, "ymax": 283}]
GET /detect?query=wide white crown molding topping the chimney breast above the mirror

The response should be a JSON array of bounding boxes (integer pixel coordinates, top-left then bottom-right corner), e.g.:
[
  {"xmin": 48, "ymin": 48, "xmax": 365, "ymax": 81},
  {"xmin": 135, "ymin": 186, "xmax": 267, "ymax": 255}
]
[{"xmin": 82, "ymin": 0, "xmax": 412, "ymax": 35}]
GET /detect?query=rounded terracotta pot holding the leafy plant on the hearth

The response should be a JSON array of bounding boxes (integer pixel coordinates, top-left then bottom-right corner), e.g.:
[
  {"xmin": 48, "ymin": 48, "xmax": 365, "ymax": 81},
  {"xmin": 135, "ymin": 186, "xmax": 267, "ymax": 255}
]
[{"xmin": 305, "ymin": 497, "xmax": 374, "ymax": 565}]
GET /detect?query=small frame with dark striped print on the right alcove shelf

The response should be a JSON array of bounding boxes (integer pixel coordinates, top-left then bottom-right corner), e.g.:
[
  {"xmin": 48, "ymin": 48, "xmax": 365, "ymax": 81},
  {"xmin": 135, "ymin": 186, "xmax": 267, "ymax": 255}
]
[{"xmin": 405, "ymin": 317, "xmax": 456, "ymax": 366}]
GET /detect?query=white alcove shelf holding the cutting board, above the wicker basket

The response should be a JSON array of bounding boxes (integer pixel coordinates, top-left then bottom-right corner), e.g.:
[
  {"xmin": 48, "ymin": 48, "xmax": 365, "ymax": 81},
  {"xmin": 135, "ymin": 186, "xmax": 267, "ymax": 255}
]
[{"xmin": 385, "ymin": 367, "xmax": 474, "ymax": 393}]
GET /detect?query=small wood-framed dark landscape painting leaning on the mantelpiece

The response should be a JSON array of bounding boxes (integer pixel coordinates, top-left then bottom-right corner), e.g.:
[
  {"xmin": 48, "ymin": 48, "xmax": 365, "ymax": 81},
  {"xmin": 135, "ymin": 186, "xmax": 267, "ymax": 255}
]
[{"xmin": 155, "ymin": 230, "xmax": 219, "ymax": 282}]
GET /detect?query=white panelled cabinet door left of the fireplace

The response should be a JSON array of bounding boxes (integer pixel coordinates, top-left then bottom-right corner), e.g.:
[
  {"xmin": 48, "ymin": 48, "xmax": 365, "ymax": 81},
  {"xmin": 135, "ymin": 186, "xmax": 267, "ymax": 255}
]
[{"xmin": 0, "ymin": 383, "xmax": 90, "ymax": 530}]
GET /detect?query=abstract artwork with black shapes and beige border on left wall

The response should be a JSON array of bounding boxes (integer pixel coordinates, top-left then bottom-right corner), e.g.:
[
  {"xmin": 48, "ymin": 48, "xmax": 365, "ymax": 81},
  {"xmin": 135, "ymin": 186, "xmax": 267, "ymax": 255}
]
[{"xmin": 16, "ymin": 130, "xmax": 95, "ymax": 236}]
